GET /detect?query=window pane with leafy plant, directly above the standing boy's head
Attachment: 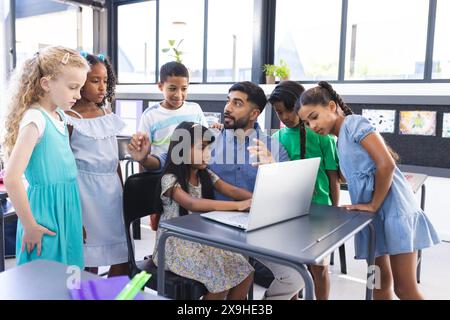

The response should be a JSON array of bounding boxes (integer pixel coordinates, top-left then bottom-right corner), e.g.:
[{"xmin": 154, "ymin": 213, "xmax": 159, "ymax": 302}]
[{"xmin": 159, "ymin": 0, "xmax": 205, "ymax": 82}]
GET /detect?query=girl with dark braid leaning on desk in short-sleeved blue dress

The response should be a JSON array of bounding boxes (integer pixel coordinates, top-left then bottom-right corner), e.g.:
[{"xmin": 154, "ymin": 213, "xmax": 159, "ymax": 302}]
[{"xmin": 297, "ymin": 81, "xmax": 439, "ymax": 299}]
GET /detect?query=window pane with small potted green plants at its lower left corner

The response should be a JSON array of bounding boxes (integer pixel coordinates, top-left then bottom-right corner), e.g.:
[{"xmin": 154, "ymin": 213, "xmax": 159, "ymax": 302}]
[{"xmin": 275, "ymin": 0, "xmax": 342, "ymax": 80}]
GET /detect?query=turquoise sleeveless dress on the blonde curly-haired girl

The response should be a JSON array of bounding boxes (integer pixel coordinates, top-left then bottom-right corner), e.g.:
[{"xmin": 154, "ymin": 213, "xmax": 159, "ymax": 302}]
[{"xmin": 16, "ymin": 110, "xmax": 84, "ymax": 268}]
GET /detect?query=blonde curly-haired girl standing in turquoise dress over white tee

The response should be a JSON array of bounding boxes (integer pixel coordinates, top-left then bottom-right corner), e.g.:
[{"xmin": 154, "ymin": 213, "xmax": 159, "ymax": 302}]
[{"xmin": 3, "ymin": 47, "xmax": 89, "ymax": 268}]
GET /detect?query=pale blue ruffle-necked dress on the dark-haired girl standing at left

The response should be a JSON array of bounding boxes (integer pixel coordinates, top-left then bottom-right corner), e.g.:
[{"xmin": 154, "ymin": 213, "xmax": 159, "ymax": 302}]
[{"xmin": 66, "ymin": 109, "xmax": 128, "ymax": 267}]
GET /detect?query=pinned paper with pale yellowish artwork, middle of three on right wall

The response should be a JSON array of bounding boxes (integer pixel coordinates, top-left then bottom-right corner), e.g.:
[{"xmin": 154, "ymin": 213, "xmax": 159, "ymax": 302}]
[{"xmin": 400, "ymin": 111, "xmax": 436, "ymax": 136}]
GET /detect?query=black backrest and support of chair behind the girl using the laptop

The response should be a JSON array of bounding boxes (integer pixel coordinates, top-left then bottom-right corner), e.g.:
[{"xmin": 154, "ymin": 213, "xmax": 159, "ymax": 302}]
[{"xmin": 123, "ymin": 172, "xmax": 160, "ymax": 272}]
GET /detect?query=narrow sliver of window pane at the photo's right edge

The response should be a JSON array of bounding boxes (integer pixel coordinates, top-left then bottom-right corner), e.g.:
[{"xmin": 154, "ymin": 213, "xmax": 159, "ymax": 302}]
[{"xmin": 433, "ymin": 0, "xmax": 450, "ymax": 79}]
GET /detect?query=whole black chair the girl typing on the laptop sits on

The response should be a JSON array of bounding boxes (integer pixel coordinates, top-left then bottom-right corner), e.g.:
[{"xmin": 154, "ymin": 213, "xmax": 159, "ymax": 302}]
[{"xmin": 123, "ymin": 172, "xmax": 206, "ymax": 300}]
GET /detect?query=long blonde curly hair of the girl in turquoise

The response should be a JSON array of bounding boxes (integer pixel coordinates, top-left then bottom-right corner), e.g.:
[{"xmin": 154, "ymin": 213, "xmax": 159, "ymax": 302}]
[{"xmin": 2, "ymin": 46, "xmax": 89, "ymax": 158}]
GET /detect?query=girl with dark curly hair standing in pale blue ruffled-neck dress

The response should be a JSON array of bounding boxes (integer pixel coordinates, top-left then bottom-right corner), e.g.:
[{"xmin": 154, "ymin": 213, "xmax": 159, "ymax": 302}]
[{"xmin": 66, "ymin": 52, "xmax": 128, "ymax": 276}]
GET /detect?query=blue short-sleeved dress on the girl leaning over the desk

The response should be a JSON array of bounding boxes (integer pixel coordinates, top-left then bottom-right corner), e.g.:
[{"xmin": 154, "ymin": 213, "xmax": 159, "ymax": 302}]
[{"xmin": 338, "ymin": 115, "xmax": 439, "ymax": 259}]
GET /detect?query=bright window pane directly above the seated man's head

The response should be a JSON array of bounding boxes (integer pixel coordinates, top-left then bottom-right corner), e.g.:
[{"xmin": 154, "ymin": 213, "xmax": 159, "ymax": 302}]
[{"xmin": 207, "ymin": 0, "xmax": 254, "ymax": 82}]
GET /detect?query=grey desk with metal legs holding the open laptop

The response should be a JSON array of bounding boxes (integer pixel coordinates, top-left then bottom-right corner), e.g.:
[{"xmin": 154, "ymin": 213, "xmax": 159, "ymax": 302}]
[{"xmin": 158, "ymin": 205, "xmax": 375, "ymax": 299}]
